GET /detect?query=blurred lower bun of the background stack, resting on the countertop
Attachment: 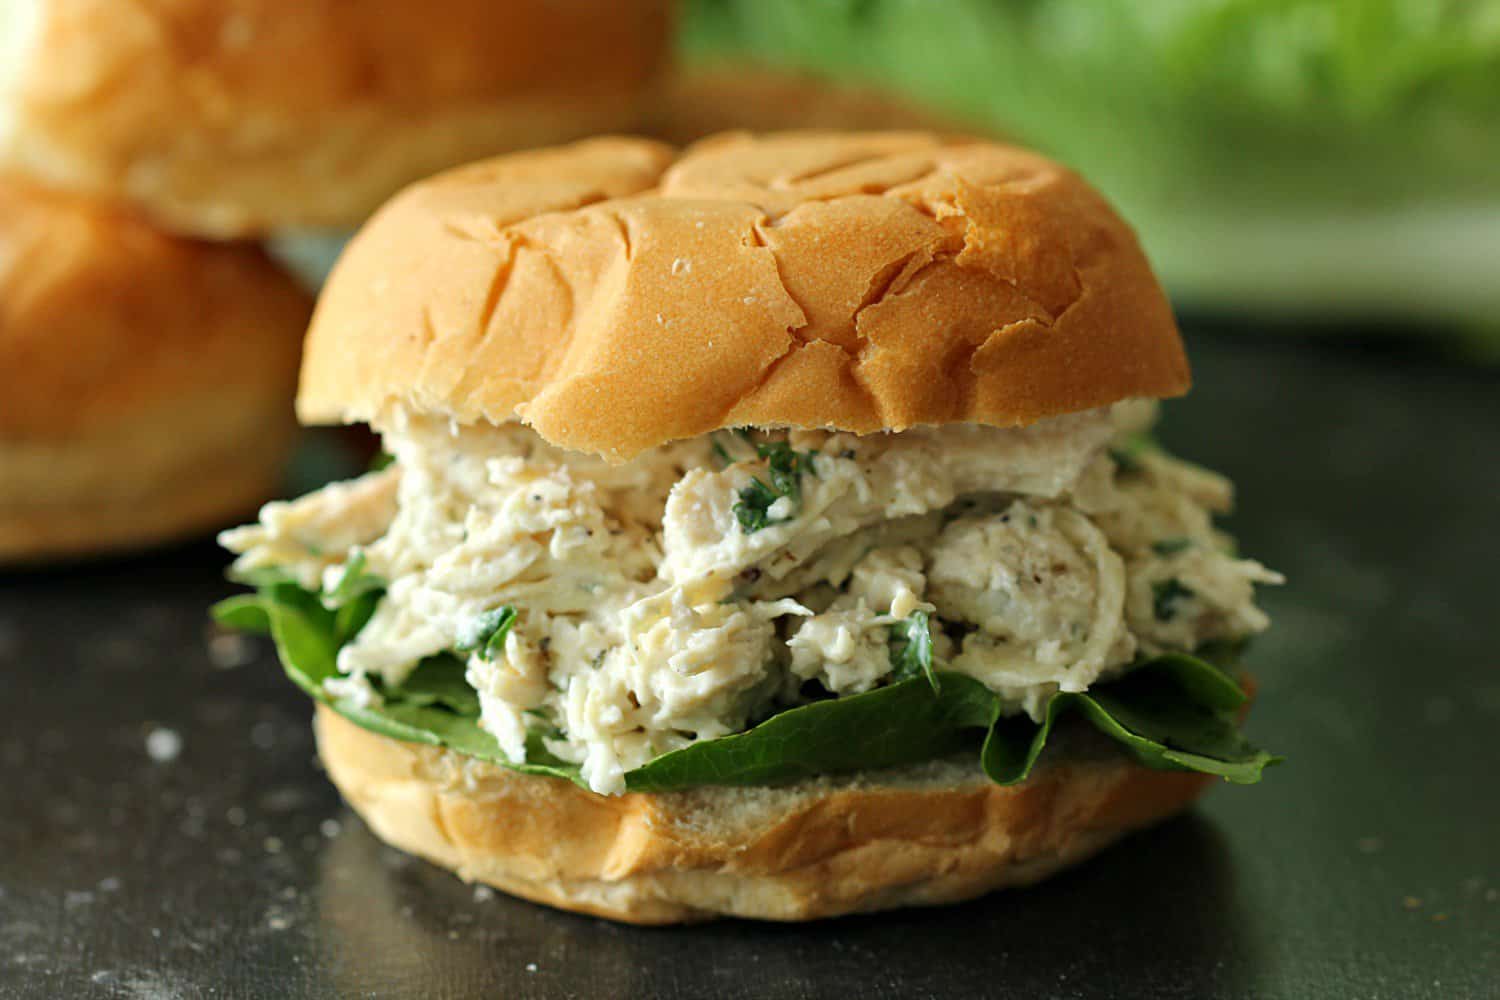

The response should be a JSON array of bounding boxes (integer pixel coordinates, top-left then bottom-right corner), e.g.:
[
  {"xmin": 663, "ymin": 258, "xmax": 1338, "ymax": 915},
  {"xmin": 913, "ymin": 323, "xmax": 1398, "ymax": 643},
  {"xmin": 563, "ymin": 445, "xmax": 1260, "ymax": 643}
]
[{"xmin": 0, "ymin": 180, "xmax": 312, "ymax": 562}]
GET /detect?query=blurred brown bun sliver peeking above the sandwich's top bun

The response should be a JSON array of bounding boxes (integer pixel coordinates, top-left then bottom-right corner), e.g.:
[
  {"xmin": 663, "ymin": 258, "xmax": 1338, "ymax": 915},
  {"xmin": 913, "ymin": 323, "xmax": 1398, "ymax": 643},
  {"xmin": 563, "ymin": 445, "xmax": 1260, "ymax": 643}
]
[{"xmin": 647, "ymin": 64, "xmax": 971, "ymax": 145}]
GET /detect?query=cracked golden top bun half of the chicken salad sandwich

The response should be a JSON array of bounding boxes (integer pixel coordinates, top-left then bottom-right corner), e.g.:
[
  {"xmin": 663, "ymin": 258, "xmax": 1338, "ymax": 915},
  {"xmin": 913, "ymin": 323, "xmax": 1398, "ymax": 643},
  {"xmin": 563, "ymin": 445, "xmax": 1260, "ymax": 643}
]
[{"xmin": 299, "ymin": 132, "xmax": 1190, "ymax": 459}]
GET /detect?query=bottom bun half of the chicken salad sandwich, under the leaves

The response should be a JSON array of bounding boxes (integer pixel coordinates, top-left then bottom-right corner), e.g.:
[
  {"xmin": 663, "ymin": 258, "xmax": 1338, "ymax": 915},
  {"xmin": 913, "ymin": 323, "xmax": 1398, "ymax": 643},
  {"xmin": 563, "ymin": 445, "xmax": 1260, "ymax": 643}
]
[{"xmin": 315, "ymin": 706, "xmax": 1211, "ymax": 924}]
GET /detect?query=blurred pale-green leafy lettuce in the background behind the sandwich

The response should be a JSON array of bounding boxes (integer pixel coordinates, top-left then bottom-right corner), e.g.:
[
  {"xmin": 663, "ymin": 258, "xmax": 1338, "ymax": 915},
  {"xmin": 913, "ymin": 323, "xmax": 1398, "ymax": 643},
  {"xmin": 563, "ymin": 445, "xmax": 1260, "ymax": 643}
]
[{"xmin": 683, "ymin": 0, "xmax": 1500, "ymax": 358}]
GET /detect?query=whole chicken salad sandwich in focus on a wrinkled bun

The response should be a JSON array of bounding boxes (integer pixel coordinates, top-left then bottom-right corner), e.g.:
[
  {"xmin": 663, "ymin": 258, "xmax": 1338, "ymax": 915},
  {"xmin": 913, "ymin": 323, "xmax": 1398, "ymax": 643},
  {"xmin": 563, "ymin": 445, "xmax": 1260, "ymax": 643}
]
[{"xmin": 215, "ymin": 132, "xmax": 1280, "ymax": 924}]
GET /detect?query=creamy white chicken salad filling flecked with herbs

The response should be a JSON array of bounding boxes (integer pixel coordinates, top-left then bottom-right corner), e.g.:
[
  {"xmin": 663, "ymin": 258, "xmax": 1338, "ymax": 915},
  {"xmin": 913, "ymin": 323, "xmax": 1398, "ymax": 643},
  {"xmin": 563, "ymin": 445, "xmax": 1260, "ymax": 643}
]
[{"xmin": 224, "ymin": 406, "xmax": 1280, "ymax": 793}]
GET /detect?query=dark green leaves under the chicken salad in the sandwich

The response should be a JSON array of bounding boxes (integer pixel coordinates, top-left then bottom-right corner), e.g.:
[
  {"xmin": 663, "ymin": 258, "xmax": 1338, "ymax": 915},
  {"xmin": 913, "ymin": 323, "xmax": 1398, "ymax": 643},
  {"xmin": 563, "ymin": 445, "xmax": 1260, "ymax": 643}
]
[{"xmin": 213, "ymin": 582, "xmax": 1278, "ymax": 792}]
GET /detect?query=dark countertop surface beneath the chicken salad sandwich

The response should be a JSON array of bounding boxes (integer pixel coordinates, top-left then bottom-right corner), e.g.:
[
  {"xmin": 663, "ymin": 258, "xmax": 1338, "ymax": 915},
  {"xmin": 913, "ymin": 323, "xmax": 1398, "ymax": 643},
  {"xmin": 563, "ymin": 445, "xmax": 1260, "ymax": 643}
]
[{"xmin": 0, "ymin": 336, "xmax": 1500, "ymax": 1000}]
